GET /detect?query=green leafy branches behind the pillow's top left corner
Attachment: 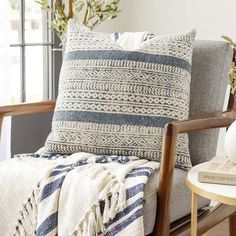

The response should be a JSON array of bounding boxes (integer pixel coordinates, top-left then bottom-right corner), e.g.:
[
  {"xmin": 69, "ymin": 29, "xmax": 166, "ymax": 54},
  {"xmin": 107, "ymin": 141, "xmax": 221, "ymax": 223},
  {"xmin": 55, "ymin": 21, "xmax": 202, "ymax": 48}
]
[{"xmin": 36, "ymin": 0, "xmax": 120, "ymax": 44}]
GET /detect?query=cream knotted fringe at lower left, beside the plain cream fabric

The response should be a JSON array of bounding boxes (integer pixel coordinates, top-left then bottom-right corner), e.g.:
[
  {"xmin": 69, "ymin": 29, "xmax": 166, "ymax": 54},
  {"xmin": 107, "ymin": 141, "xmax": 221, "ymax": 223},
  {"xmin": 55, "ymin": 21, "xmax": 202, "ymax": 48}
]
[{"xmin": 13, "ymin": 184, "xmax": 40, "ymax": 236}]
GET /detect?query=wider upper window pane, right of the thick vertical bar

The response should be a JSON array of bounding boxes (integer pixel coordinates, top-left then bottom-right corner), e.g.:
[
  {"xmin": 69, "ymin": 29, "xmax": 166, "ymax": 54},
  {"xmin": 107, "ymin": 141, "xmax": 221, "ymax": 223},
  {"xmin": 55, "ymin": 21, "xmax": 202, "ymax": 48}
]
[{"xmin": 25, "ymin": 0, "xmax": 43, "ymax": 43}]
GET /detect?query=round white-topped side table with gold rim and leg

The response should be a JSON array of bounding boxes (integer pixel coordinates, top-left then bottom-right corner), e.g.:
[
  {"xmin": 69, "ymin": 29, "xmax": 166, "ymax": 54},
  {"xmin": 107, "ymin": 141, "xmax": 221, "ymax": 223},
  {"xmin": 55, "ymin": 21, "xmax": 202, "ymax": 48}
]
[{"xmin": 186, "ymin": 162, "xmax": 236, "ymax": 236}]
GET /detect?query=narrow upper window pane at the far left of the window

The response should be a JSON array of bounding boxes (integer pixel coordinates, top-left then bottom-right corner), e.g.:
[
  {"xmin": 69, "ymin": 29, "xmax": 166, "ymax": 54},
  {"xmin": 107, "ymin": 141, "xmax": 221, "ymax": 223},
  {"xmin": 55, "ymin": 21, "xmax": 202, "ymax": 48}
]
[{"xmin": 9, "ymin": 0, "xmax": 20, "ymax": 43}]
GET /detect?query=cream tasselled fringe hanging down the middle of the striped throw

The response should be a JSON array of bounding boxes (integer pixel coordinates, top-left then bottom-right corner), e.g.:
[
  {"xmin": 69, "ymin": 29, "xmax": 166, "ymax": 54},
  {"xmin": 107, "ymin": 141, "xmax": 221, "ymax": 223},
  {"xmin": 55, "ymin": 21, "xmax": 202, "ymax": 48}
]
[{"xmin": 72, "ymin": 166, "xmax": 126, "ymax": 236}]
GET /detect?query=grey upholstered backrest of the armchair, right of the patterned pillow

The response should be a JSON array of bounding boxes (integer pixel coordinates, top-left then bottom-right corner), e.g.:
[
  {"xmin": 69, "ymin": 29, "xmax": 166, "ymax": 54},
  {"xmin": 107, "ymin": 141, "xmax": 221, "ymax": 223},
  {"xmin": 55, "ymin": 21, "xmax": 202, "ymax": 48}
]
[{"xmin": 189, "ymin": 40, "xmax": 233, "ymax": 165}]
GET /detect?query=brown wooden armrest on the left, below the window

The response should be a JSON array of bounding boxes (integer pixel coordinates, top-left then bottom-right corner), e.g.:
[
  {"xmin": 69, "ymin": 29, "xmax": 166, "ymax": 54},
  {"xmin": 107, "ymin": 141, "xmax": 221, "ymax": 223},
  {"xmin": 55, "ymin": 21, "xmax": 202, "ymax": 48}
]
[{"xmin": 0, "ymin": 100, "xmax": 56, "ymax": 137}]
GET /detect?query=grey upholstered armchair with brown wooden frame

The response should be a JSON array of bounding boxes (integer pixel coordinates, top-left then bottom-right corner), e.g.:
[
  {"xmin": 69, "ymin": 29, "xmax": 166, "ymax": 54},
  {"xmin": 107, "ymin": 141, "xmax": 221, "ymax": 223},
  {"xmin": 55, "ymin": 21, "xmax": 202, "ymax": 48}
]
[{"xmin": 0, "ymin": 41, "xmax": 236, "ymax": 236}]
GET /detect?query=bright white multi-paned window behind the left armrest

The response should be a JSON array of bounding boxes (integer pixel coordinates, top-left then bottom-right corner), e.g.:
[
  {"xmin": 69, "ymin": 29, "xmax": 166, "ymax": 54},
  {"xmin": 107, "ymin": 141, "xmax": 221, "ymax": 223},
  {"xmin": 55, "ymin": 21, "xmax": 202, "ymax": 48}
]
[{"xmin": 8, "ymin": 0, "xmax": 53, "ymax": 103}]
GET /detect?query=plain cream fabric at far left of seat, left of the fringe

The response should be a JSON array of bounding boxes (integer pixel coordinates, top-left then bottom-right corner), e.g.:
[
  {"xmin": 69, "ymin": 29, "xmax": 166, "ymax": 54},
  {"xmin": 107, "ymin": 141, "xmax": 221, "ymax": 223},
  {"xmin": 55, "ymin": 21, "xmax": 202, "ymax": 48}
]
[{"xmin": 0, "ymin": 158, "xmax": 57, "ymax": 236}]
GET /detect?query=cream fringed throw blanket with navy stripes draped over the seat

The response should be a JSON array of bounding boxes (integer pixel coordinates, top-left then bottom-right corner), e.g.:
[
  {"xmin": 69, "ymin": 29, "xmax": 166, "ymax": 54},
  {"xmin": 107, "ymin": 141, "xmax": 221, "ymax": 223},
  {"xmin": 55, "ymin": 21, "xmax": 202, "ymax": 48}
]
[{"xmin": 0, "ymin": 153, "xmax": 159, "ymax": 236}]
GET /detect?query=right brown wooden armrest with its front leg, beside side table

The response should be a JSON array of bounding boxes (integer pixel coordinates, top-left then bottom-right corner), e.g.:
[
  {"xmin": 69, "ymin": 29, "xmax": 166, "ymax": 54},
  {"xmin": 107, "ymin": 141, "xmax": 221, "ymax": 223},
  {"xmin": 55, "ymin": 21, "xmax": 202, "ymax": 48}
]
[{"xmin": 155, "ymin": 110, "xmax": 236, "ymax": 235}]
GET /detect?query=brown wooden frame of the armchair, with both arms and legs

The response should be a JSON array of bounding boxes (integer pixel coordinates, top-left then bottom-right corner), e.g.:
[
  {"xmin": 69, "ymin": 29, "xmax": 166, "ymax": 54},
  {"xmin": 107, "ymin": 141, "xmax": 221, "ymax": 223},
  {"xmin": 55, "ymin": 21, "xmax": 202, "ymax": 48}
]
[{"xmin": 0, "ymin": 50, "xmax": 236, "ymax": 236}]
